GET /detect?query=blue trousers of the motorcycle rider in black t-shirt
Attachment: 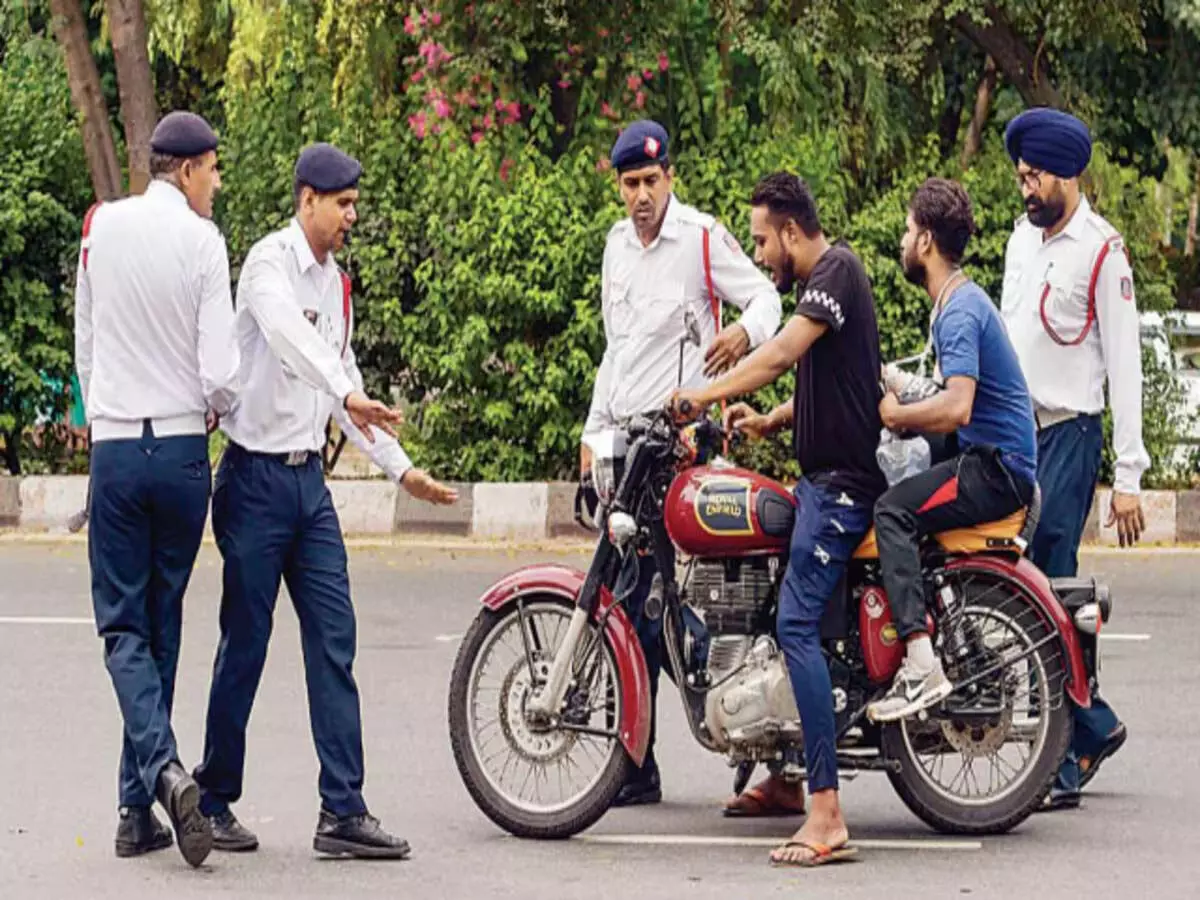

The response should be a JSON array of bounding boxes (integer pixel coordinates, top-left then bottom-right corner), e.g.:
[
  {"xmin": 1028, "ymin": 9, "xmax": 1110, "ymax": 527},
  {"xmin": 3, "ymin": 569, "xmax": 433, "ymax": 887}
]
[{"xmin": 776, "ymin": 478, "xmax": 872, "ymax": 793}]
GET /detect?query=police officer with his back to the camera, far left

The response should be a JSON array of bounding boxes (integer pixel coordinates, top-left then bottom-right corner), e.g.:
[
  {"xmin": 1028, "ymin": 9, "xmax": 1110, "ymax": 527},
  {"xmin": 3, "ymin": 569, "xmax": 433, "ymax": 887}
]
[{"xmin": 76, "ymin": 112, "xmax": 238, "ymax": 865}]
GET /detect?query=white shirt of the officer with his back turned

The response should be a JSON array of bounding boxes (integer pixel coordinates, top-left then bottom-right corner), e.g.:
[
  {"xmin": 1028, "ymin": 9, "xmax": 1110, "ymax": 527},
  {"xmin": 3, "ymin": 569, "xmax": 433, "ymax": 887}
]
[{"xmin": 74, "ymin": 180, "xmax": 238, "ymax": 440}]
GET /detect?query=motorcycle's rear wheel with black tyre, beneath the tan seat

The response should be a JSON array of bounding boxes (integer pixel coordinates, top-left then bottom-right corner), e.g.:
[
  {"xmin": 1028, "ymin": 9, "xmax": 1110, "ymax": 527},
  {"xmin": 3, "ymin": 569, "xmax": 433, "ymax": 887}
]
[{"xmin": 882, "ymin": 574, "xmax": 1072, "ymax": 835}]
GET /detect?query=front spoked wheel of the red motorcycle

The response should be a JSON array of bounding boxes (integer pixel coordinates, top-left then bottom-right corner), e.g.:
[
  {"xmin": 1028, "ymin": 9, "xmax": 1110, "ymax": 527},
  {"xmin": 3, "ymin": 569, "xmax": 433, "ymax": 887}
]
[{"xmin": 449, "ymin": 596, "xmax": 630, "ymax": 839}]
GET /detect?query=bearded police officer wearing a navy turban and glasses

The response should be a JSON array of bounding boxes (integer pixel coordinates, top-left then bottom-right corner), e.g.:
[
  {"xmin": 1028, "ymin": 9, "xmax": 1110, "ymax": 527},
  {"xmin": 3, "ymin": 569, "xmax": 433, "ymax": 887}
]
[{"xmin": 1001, "ymin": 108, "xmax": 1150, "ymax": 809}]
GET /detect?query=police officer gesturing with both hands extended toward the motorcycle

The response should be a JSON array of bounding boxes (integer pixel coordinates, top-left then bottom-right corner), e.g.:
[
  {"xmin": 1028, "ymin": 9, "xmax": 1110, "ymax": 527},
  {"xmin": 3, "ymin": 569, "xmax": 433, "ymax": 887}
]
[{"xmin": 196, "ymin": 144, "xmax": 457, "ymax": 858}]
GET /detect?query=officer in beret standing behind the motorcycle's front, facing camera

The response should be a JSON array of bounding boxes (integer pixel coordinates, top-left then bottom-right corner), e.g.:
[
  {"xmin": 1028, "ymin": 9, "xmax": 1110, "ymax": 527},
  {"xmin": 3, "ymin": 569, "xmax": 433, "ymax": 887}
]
[{"xmin": 580, "ymin": 120, "xmax": 782, "ymax": 806}]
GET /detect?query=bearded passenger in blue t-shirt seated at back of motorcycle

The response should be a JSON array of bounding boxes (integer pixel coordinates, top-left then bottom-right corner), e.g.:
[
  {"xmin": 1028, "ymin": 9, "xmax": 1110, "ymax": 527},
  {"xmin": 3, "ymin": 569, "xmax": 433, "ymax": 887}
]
[{"xmin": 868, "ymin": 179, "xmax": 1037, "ymax": 722}]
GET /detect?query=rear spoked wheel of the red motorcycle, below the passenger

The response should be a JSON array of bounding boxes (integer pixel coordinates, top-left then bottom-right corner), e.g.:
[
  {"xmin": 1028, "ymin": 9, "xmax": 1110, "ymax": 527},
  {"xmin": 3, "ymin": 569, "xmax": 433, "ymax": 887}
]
[{"xmin": 883, "ymin": 572, "xmax": 1070, "ymax": 834}]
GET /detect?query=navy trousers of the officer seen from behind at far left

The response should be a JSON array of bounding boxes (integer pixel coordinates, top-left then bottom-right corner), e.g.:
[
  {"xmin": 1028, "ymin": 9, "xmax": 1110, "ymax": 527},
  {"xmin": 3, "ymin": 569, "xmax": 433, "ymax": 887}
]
[{"xmin": 88, "ymin": 422, "xmax": 211, "ymax": 806}]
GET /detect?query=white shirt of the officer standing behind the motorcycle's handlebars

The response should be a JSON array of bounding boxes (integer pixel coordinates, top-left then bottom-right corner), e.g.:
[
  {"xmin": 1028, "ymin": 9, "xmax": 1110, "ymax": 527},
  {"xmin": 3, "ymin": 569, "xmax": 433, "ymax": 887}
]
[{"xmin": 583, "ymin": 194, "xmax": 782, "ymax": 434}]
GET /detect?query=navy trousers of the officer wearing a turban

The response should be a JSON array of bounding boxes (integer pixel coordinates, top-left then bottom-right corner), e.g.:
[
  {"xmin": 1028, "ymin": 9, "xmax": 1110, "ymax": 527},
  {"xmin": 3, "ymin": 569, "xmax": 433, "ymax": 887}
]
[{"xmin": 1030, "ymin": 415, "xmax": 1118, "ymax": 791}]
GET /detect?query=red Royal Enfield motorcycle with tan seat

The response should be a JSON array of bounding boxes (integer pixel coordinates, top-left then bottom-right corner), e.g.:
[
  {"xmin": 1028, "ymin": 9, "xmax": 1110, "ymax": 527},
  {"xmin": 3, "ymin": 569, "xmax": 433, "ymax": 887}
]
[{"xmin": 449, "ymin": 412, "xmax": 1111, "ymax": 839}]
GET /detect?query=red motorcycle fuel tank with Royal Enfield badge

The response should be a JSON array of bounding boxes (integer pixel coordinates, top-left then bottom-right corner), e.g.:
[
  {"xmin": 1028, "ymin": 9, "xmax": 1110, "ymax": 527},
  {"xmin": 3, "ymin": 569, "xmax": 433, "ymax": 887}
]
[{"xmin": 664, "ymin": 466, "xmax": 796, "ymax": 557}]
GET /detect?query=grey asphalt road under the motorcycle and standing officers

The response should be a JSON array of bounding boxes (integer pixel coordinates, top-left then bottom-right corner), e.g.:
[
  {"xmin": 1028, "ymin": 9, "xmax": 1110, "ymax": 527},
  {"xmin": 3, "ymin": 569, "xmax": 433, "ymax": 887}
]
[{"xmin": 0, "ymin": 540, "xmax": 1200, "ymax": 900}]
